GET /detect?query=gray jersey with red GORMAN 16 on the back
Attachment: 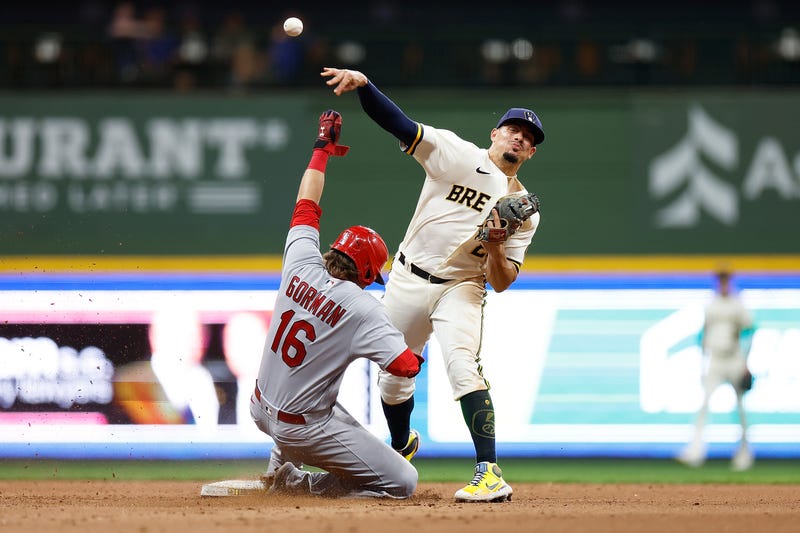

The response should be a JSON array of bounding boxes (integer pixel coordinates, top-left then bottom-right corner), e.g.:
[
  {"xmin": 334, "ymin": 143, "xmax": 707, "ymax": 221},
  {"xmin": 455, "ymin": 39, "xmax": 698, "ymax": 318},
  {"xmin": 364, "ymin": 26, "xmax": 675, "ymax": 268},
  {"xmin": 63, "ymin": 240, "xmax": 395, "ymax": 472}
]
[{"xmin": 258, "ymin": 225, "xmax": 406, "ymax": 414}]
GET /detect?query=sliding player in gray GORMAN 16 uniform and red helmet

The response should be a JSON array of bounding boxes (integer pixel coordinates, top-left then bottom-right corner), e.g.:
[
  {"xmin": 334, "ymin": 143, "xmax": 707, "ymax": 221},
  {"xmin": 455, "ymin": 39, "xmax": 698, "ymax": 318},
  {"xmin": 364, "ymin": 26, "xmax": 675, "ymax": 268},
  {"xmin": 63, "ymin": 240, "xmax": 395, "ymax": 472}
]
[{"xmin": 250, "ymin": 110, "xmax": 422, "ymax": 498}]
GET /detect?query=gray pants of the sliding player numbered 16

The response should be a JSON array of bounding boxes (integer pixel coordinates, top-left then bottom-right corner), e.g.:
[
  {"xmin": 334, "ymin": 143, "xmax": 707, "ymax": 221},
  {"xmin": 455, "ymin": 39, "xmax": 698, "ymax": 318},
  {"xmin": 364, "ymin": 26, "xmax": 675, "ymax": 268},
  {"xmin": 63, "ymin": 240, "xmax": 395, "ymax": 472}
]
[{"xmin": 250, "ymin": 398, "xmax": 418, "ymax": 498}]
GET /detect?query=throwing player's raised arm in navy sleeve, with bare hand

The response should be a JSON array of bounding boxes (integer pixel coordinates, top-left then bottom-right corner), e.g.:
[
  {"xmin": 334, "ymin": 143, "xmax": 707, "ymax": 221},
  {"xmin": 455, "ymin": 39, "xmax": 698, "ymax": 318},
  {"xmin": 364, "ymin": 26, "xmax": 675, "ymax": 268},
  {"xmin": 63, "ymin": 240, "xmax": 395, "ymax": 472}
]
[{"xmin": 320, "ymin": 67, "xmax": 421, "ymax": 146}]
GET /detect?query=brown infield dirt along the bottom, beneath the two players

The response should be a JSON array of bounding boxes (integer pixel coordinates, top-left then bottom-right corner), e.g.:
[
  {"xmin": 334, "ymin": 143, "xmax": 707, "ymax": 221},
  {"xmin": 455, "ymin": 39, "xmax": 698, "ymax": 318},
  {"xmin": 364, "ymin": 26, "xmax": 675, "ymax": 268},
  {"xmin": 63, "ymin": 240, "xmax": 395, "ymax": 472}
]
[{"xmin": 0, "ymin": 481, "xmax": 800, "ymax": 533}]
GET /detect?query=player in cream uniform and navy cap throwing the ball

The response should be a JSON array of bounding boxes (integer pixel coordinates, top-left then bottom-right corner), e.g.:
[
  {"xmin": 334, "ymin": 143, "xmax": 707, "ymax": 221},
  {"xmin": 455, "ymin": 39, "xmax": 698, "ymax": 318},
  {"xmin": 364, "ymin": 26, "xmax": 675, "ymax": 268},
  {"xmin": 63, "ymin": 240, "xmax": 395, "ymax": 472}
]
[{"xmin": 321, "ymin": 68, "xmax": 544, "ymax": 501}]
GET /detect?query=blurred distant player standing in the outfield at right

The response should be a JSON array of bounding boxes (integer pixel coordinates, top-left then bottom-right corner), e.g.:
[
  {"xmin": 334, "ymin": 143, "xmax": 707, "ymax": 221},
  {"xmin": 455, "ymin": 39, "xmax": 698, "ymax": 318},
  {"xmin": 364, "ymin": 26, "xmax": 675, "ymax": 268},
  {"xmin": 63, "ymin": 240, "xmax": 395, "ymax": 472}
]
[{"xmin": 678, "ymin": 271, "xmax": 753, "ymax": 470}]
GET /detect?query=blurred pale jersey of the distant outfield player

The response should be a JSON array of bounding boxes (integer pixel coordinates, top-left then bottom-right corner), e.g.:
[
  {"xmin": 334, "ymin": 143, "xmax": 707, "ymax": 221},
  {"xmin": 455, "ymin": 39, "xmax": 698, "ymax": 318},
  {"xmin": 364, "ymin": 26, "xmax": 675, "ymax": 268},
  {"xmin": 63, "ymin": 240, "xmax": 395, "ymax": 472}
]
[{"xmin": 703, "ymin": 294, "xmax": 752, "ymax": 357}]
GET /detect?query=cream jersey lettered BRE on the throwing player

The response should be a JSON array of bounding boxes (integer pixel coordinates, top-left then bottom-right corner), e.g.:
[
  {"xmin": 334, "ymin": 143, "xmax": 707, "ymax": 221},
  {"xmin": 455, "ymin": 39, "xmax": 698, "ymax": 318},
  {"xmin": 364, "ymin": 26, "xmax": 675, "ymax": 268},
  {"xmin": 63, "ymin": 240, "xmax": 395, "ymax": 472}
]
[{"xmin": 399, "ymin": 125, "xmax": 539, "ymax": 279}]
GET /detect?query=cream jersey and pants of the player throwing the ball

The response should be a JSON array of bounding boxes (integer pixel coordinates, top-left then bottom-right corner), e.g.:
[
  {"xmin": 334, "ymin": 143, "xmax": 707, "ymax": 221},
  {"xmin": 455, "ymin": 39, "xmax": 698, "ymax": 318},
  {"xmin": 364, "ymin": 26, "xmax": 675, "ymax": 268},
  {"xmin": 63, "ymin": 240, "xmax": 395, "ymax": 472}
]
[{"xmin": 378, "ymin": 125, "xmax": 539, "ymax": 404}]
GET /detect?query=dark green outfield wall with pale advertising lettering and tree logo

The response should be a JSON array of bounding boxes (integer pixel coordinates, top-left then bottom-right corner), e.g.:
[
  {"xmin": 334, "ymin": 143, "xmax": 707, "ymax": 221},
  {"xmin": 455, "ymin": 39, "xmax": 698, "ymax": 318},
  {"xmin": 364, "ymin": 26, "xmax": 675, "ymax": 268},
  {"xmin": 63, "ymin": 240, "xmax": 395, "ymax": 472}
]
[{"xmin": 0, "ymin": 87, "xmax": 800, "ymax": 258}]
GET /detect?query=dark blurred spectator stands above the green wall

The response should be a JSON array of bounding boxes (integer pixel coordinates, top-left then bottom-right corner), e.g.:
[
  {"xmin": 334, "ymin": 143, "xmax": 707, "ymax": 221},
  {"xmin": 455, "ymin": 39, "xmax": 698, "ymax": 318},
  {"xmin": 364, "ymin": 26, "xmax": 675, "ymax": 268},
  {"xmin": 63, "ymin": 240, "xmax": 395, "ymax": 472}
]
[{"xmin": 0, "ymin": 0, "xmax": 800, "ymax": 91}]
